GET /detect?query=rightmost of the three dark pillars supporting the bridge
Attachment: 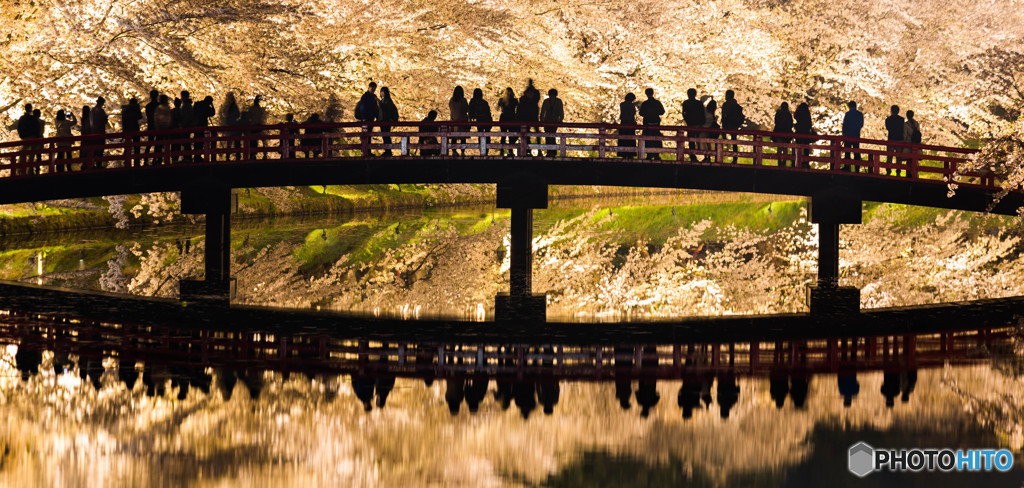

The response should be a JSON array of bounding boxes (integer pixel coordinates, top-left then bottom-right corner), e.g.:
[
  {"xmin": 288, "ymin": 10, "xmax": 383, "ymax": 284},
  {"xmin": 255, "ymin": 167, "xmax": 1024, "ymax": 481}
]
[{"xmin": 807, "ymin": 190, "xmax": 863, "ymax": 314}]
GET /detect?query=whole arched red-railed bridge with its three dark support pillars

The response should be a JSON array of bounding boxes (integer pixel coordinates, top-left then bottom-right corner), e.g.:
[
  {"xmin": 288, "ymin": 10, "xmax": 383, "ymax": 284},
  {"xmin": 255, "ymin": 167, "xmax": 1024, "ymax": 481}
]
[{"xmin": 0, "ymin": 123, "xmax": 1024, "ymax": 318}]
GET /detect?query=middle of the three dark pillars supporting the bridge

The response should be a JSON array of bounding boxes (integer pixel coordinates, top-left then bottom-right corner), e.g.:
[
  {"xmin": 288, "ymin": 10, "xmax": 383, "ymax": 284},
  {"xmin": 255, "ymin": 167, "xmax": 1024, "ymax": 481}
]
[{"xmin": 495, "ymin": 177, "xmax": 548, "ymax": 321}]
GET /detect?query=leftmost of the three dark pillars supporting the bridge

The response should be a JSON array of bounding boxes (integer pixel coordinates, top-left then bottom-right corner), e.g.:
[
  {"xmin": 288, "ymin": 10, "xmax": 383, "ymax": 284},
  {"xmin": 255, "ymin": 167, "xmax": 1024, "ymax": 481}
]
[{"xmin": 179, "ymin": 186, "xmax": 238, "ymax": 304}]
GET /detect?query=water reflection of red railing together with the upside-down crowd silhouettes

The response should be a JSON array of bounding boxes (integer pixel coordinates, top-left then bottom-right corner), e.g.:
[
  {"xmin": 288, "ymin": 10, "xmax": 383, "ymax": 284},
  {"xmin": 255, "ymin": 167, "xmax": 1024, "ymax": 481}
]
[{"xmin": 0, "ymin": 306, "xmax": 1016, "ymax": 417}]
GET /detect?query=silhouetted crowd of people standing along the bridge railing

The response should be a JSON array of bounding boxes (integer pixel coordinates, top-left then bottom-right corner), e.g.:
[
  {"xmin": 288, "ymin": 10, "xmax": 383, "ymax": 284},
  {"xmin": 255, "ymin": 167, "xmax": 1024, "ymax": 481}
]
[{"xmin": 9, "ymin": 80, "xmax": 922, "ymax": 172}]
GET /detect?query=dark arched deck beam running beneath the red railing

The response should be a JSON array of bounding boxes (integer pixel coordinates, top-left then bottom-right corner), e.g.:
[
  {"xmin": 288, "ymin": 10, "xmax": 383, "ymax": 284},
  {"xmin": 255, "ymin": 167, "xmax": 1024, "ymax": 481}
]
[{"xmin": 0, "ymin": 158, "xmax": 1024, "ymax": 215}]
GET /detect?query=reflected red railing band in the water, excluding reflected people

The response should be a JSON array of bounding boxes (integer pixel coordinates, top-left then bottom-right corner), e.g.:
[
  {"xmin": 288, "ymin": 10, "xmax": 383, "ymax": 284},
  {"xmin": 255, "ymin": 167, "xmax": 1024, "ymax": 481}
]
[{"xmin": 0, "ymin": 311, "xmax": 1014, "ymax": 382}]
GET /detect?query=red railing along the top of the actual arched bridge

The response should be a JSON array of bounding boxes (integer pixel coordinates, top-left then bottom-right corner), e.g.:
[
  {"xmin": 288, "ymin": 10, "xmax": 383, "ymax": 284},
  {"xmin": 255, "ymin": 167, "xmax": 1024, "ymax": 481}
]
[{"xmin": 0, "ymin": 122, "xmax": 1001, "ymax": 189}]
